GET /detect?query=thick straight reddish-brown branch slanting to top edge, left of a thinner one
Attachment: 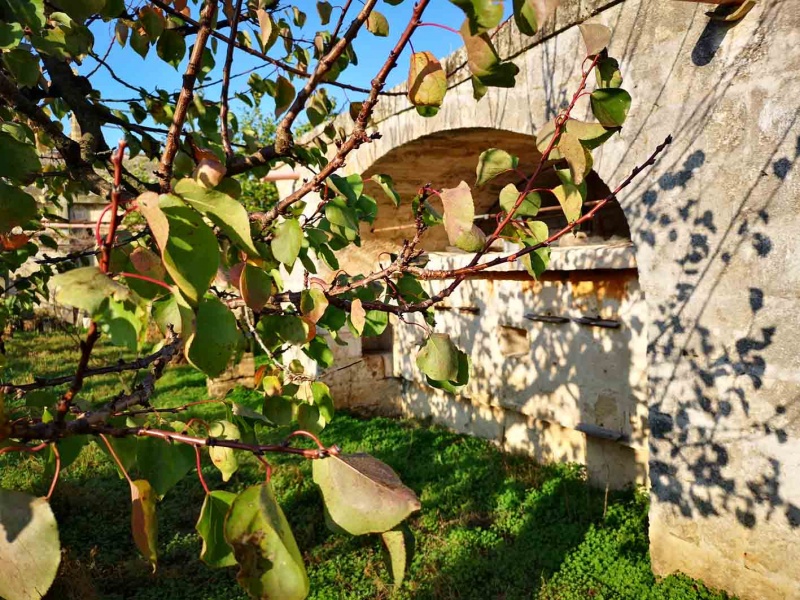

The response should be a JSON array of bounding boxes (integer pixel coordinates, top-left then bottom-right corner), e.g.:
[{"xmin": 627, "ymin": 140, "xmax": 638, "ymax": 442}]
[{"xmin": 156, "ymin": 0, "xmax": 217, "ymax": 193}]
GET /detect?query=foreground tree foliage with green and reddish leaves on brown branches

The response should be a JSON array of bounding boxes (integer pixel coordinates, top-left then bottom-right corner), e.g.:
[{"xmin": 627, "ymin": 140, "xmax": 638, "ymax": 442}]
[{"xmin": 0, "ymin": 0, "xmax": 664, "ymax": 600}]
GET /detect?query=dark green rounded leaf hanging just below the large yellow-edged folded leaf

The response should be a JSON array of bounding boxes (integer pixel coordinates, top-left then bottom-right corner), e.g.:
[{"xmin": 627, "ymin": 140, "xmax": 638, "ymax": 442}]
[{"xmin": 186, "ymin": 294, "xmax": 239, "ymax": 377}]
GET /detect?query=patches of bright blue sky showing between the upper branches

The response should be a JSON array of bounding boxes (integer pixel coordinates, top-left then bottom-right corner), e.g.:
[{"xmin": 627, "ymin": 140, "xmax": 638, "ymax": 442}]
[{"xmin": 80, "ymin": 0, "xmax": 506, "ymax": 139}]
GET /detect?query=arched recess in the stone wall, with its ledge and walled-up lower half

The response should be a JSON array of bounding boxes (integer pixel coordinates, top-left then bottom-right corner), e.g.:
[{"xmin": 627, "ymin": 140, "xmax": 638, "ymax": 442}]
[{"xmin": 322, "ymin": 128, "xmax": 647, "ymax": 487}]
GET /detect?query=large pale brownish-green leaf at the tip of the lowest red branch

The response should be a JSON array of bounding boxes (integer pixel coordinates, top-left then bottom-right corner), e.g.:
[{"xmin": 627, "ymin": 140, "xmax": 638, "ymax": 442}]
[{"xmin": 311, "ymin": 454, "xmax": 420, "ymax": 535}]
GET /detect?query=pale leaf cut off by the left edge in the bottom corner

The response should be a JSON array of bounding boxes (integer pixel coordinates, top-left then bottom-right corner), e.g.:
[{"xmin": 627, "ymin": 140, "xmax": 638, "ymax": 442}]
[{"xmin": 0, "ymin": 489, "xmax": 61, "ymax": 600}]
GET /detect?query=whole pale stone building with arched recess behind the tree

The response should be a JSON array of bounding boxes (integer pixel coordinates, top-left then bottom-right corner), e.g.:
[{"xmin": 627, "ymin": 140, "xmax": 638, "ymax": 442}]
[{"xmin": 282, "ymin": 0, "xmax": 800, "ymax": 600}]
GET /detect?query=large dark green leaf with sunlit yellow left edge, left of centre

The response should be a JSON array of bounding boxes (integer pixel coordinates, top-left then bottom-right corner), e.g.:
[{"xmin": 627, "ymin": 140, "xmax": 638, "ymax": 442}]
[{"xmin": 156, "ymin": 195, "xmax": 219, "ymax": 303}]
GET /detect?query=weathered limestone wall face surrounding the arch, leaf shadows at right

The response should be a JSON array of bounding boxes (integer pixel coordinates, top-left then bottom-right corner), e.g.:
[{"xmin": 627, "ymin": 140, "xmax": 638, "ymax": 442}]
[{"xmin": 280, "ymin": 0, "xmax": 800, "ymax": 600}]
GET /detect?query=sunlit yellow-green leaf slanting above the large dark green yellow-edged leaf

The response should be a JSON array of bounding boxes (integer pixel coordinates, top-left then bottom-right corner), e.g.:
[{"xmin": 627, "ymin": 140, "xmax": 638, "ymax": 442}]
[{"xmin": 175, "ymin": 177, "xmax": 258, "ymax": 257}]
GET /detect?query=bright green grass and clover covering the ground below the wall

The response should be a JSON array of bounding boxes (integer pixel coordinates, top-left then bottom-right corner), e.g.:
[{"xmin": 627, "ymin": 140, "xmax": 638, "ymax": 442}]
[{"xmin": 0, "ymin": 335, "xmax": 727, "ymax": 600}]
